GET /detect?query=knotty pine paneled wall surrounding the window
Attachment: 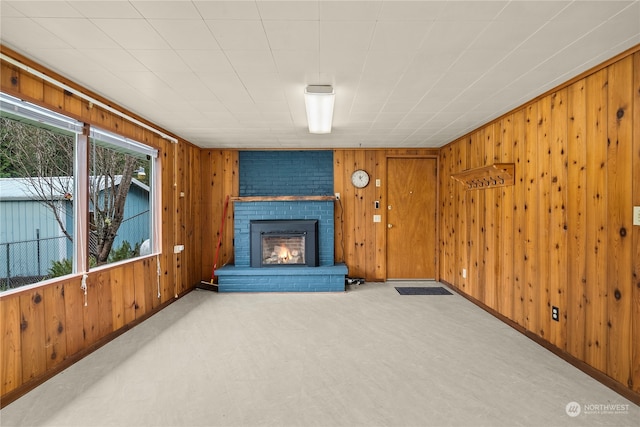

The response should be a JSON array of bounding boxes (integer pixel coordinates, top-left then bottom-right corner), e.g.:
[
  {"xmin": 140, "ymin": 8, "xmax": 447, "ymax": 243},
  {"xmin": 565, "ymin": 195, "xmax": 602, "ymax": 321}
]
[{"xmin": 0, "ymin": 47, "xmax": 202, "ymax": 405}]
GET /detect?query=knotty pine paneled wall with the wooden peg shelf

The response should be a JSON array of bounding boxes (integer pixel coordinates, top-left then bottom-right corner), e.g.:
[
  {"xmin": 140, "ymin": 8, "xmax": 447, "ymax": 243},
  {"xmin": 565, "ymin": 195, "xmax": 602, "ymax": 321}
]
[{"xmin": 440, "ymin": 48, "xmax": 640, "ymax": 400}]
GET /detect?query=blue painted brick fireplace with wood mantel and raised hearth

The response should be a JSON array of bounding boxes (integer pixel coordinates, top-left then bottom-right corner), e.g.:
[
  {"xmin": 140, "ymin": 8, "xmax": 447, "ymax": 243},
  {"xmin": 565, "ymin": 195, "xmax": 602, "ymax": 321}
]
[{"xmin": 216, "ymin": 151, "xmax": 347, "ymax": 292}]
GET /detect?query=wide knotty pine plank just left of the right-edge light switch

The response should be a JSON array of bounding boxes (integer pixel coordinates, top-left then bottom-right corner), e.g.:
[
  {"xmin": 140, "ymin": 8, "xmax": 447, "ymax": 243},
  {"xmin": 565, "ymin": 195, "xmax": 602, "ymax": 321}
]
[{"xmin": 607, "ymin": 57, "xmax": 633, "ymax": 383}]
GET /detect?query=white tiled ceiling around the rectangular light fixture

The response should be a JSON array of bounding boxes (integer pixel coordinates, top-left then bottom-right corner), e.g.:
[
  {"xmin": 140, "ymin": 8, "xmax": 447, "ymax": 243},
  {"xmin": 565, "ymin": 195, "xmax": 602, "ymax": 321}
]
[{"xmin": 0, "ymin": 0, "xmax": 640, "ymax": 148}]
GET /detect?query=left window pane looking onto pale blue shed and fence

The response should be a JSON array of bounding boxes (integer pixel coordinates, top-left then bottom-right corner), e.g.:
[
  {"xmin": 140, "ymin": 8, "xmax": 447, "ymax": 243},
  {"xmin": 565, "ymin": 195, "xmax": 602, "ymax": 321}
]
[{"xmin": 0, "ymin": 94, "xmax": 82, "ymax": 291}]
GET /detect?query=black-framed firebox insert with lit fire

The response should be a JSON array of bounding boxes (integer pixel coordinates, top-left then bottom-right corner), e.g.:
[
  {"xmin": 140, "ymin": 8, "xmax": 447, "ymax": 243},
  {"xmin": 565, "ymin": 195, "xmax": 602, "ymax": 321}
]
[{"xmin": 249, "ymin": 220, "xmax": 319, "ymax": 267}]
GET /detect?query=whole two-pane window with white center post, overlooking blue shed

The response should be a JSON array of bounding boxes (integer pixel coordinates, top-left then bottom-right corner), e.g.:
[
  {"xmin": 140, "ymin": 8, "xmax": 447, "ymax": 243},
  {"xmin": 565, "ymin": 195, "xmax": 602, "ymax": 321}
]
[{"xmin": 0, "ymin": 93, "xmax": 159, "ymax": 291}]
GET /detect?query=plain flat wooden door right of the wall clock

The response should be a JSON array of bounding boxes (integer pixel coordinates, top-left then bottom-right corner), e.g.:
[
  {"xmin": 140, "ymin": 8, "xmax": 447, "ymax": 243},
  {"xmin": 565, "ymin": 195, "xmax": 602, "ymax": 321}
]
[{"xmin": 387, "ymin": 158, "xmax": 438, "ymax": 279}]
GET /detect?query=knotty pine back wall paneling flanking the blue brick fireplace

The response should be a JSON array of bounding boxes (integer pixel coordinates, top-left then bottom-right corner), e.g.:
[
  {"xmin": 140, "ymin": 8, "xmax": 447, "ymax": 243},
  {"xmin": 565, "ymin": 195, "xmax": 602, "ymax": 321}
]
[{"xmin": 200, "ymin": 149, "xmax": 439, "ymax": 281}]
